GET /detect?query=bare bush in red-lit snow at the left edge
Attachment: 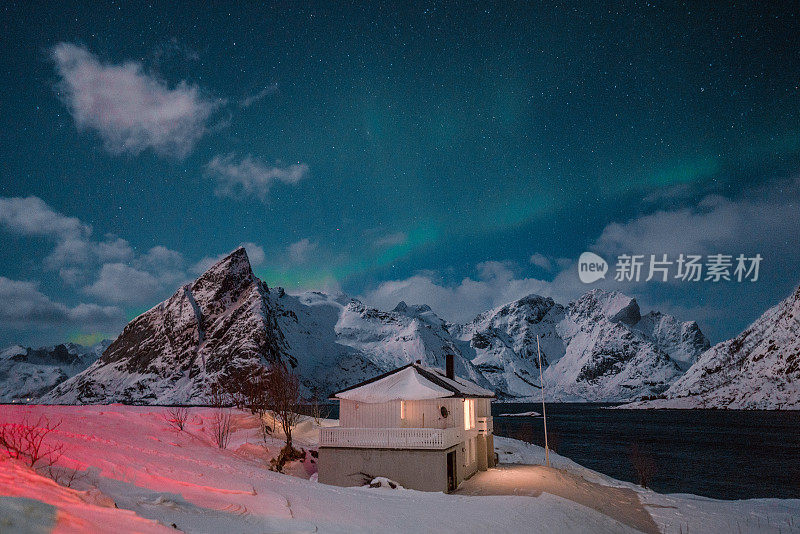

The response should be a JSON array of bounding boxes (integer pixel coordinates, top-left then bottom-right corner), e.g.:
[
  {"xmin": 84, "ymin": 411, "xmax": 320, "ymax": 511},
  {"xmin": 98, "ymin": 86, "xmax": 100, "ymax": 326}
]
[{"xmin": 0, "ymin": 415, "xmax": 64, "ymax": 468}]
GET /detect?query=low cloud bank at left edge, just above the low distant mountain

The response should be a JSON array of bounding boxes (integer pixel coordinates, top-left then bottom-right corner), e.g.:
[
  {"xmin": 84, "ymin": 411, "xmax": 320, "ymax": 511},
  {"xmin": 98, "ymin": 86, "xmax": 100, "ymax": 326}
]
[{"xmin": 0, "ymin": 276, "xmax": 125, "ymax": 330}]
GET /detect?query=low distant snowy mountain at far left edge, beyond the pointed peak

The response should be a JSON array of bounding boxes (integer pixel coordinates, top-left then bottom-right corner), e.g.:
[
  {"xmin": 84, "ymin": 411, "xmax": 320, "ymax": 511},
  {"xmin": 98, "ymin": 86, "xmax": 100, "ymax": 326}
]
[{"xmin": 0, "ymin": 340, "xmax": 111, "ymax": 402}]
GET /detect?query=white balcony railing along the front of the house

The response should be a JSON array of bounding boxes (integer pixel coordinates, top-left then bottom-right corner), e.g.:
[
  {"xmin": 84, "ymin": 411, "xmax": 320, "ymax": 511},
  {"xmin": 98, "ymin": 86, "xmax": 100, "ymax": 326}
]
[{"xmin": 319, "ymin": 427, "xmax": 464, "ymax": 449}]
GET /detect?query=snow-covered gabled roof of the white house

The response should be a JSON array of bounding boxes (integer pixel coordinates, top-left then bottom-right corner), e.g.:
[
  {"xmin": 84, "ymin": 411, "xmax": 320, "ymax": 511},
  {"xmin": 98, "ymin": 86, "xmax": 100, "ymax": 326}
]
[{"xmin": 330, "ymin": 363, "xmax": 494, "ymax": 403}]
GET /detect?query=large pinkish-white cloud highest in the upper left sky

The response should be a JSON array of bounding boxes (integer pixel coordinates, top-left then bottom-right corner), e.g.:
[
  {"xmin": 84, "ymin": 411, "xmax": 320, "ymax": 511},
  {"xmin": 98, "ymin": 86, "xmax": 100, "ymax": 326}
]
[{"xmin": 51, "ymin": 43, "xmax": 220, "ymax": 158}]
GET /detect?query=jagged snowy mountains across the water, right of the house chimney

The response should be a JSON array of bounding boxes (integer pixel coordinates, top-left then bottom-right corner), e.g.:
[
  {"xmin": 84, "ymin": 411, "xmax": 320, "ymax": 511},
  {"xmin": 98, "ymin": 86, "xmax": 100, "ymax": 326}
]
[{"xmin": 451, "ymin": 290, "xmax": 709, "ymax": 401}]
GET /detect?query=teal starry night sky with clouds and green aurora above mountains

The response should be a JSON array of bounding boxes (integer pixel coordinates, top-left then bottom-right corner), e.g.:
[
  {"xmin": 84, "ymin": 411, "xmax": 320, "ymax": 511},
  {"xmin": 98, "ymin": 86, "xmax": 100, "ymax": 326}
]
[{"xmin": 0, "ymin": 2, "xmax": 800, "ymax": 345}]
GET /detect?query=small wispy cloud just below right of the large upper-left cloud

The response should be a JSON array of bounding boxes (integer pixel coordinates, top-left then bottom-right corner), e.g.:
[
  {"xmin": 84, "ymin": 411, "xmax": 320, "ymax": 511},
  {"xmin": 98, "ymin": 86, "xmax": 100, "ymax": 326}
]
[{"xmin": 205, "ymin": 154, "xmax": 308, "ymax": 201}]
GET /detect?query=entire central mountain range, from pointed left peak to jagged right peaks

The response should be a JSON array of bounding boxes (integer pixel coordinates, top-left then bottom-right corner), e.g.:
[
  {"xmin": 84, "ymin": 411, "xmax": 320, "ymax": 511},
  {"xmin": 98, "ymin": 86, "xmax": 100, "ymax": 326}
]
[{"xmin": 32, "ymin": 248, "xmax": 708, "ymax": 404}]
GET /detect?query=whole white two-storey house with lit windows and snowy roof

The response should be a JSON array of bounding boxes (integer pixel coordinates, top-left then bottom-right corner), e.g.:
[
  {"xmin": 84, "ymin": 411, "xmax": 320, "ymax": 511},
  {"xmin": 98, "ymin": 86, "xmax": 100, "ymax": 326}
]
[{"xmin": 318, "ymin": 356, "xmax": 495, "ymax": 492}]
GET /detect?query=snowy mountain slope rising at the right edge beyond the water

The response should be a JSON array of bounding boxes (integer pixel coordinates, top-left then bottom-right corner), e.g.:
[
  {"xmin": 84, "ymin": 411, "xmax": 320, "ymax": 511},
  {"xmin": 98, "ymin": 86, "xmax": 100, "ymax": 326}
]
[{"xmin": 630, "ymin": 287, "xmax": 800, "ymax": 410}]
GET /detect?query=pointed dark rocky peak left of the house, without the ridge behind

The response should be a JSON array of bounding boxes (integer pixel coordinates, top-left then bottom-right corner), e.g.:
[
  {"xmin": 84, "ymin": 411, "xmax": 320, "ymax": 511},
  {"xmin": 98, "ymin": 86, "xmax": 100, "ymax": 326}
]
[{"xmin": 43, "ymin": 247, "xmax": 293, "ymax": 404}]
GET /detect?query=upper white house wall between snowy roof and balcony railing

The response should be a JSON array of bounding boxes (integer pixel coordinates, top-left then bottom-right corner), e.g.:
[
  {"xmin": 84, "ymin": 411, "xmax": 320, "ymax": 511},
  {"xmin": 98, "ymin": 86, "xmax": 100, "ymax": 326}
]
[{"xmin": 339, "ymin": 398, "xmax": 468, "ymax": 428}]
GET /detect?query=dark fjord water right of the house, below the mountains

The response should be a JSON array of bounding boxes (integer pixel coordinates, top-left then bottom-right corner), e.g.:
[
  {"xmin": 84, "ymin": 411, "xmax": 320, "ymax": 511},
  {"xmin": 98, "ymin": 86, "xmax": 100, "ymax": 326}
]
[{"xmin": 324, "ymin": 403, "xmax": 800, "ymax": 499}]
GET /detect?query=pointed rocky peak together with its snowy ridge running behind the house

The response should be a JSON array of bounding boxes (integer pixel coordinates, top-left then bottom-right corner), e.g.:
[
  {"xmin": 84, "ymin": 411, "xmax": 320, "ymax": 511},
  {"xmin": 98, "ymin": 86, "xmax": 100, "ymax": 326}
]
[{"xmin": 43, "ymin": 248, "xmax": 489, "ymax": 404}]
